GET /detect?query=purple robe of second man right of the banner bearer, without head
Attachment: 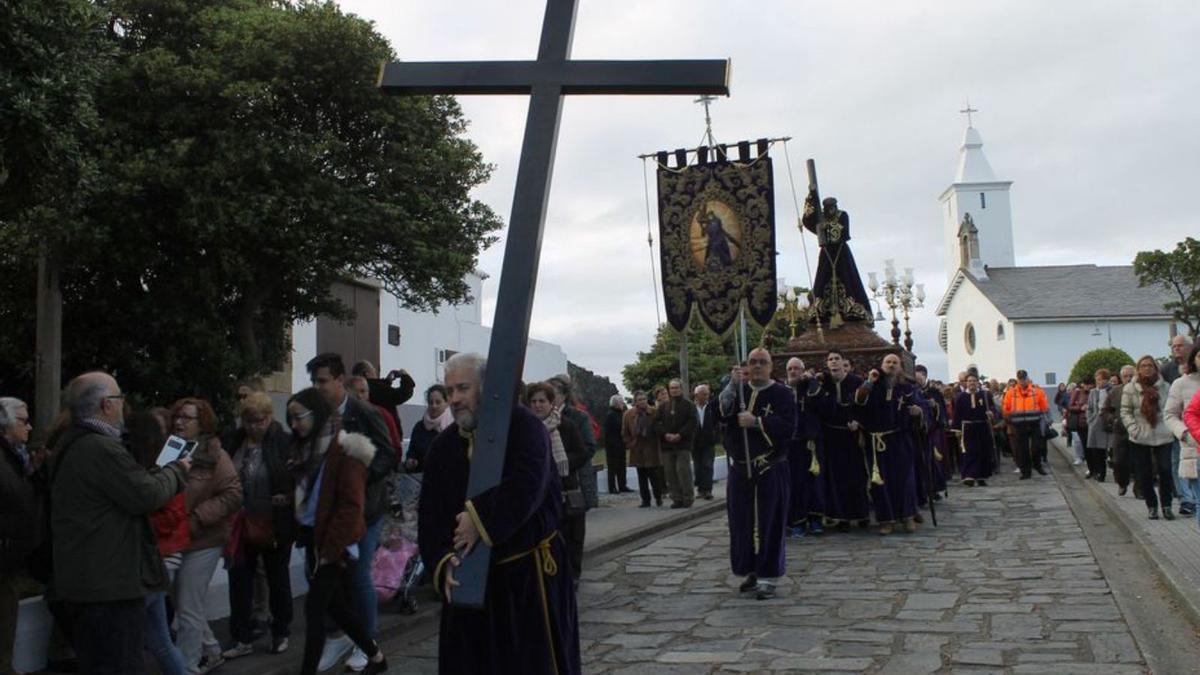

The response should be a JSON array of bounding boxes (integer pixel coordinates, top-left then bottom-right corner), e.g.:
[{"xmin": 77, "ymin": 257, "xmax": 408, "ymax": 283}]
[{"xmin": 815, "ymin": 374, "xmax": 870, "ymax": 522}]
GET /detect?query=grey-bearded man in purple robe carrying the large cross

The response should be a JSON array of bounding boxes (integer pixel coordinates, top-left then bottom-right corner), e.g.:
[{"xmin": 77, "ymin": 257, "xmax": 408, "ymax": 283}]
[{"xmin": 418, "ymin": 353, "xmax": 581, "ymax": 675}]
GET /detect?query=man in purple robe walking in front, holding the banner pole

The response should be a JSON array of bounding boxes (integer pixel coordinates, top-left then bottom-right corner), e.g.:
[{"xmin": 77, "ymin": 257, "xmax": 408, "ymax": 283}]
[{"xmin": 719, "ymin": 347, "xmax": 796, "ymax": 601}]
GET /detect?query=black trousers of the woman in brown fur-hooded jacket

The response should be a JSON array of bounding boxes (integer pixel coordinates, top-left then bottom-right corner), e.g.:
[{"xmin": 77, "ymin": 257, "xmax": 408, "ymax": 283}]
[{"xmin": 300, "ymin": 546, "xmax": 379, "ymax": 675}]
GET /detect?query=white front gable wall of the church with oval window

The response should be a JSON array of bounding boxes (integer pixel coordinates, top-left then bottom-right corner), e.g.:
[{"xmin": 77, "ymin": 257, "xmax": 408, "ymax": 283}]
[{"xmin": 946, "ymin": 281, "xmax": 1015, "ymax": 381}]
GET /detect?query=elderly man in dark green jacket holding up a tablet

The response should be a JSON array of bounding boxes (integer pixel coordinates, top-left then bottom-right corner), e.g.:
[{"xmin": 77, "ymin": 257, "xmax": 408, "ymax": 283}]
[{"xmin": 50, "ymin": 372, "xmax": 191, "ymax": 675}]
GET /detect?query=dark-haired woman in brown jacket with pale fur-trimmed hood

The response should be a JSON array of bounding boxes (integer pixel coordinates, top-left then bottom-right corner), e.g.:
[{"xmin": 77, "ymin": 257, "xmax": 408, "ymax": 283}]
[{"xmin": 288, "ymin": 388, "xmax": 388, "ymax": 675}]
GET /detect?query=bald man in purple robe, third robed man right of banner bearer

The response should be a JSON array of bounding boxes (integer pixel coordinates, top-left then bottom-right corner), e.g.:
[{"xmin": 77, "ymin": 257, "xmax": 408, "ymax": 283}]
[{"xmin": 854, "ymin": 353, "xmax": 929, "ymax": 534}]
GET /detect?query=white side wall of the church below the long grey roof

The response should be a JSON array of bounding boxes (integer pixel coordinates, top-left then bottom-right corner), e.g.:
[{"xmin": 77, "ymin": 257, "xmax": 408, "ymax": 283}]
[{"xmin": 1014, "ymin": 319, "xmax": 1170, "ymax": 387}]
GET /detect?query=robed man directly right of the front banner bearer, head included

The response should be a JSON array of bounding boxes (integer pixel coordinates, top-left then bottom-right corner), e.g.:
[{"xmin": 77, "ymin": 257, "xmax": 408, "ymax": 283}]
[{"xmin": 786, "ymin": 357, "xmax": 824, "ymax": 539}]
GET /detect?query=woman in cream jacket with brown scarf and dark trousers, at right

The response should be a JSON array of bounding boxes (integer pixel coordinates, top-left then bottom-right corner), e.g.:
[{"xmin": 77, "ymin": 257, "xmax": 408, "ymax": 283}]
[{"xmin": 1121, "ymin": 356, "xmax": 1175, "ymax": 520}]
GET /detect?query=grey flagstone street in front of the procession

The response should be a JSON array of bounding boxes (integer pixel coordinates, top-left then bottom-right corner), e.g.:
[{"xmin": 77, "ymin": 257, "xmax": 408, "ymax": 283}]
[{"xmin": 389, "ymin": 462, "xmax": 1147, "ymax": 675}]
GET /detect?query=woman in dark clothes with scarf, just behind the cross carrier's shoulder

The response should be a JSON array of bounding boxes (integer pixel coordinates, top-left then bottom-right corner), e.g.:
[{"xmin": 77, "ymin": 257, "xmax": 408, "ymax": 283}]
[{"xmin": 526, "ymin": 382, "xmax": 588, "ymax": 587}]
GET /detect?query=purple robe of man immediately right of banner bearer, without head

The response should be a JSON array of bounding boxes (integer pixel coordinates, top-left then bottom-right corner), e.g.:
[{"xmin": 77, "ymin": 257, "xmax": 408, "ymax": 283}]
[{"xmin": 787, "ymin": 380, "xmax": 826, "ymax": 527}]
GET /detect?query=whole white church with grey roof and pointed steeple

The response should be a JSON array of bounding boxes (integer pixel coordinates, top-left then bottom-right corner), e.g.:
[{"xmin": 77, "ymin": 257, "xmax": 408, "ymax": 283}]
[{"xmin": 937, "ymin": 121, "xmax": 1178, "ymax": 387}]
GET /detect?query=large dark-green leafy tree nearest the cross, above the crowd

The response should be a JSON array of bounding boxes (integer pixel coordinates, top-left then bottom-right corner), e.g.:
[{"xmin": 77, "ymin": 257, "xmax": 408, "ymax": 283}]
[{"xmin": 0, "ymin": 0, "xmax": 500, "ymax": 401}]
